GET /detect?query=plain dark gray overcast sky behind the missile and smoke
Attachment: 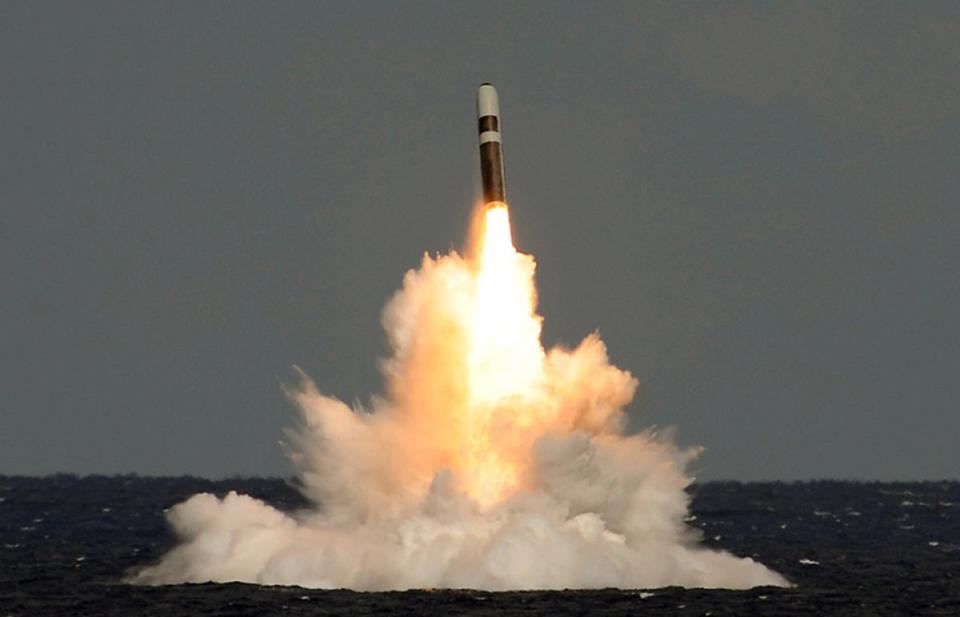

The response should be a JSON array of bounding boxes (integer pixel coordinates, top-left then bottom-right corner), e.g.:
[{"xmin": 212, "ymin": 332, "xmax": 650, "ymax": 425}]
[{"xmin": 0, "ymin": 1, "xmax": 960, "ymax": 479}]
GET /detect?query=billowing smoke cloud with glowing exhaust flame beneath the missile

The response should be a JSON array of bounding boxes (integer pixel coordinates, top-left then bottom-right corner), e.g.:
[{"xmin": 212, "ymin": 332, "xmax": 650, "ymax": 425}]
[{"xmin": 131, "ymin": 208, "xmax": 787, "ymax": 590}]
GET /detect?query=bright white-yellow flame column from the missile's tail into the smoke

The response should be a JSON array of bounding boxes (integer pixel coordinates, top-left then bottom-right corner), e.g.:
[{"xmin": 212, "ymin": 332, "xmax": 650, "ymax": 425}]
[{"xmin": 460, "ymin": 202, "xmax": 544, "ymax": 506}]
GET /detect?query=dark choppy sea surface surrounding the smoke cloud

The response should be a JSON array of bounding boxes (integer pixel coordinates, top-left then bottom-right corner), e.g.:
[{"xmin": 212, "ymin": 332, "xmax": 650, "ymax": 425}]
[{"xmin": 0, "ymin": 475, "xmax": 960, "ymax": 617}]
